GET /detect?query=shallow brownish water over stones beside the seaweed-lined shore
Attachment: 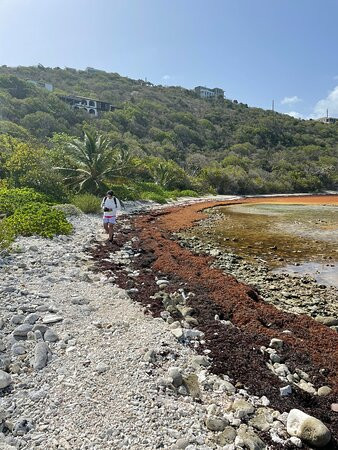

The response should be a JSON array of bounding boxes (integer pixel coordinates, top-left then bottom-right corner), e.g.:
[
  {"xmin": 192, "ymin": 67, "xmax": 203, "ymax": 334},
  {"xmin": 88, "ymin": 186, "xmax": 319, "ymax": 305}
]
[{"xmin": 204, "ymin": 204, "xmax": 338, "ymax": 286}]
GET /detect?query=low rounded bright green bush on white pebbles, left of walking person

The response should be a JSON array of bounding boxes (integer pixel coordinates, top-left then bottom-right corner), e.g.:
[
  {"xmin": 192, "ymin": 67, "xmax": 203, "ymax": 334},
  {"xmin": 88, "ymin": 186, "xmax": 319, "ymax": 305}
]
[{"xmin": 2, "ymin": 203, "xmax": 73, "ymax": 238}]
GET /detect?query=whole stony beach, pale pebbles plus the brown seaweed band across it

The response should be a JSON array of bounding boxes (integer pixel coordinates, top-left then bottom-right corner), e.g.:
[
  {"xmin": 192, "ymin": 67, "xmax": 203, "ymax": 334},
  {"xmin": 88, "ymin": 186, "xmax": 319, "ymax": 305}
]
[{"xmin": 0, "ymin": 199, "xmax": 338, "ymax": 450}]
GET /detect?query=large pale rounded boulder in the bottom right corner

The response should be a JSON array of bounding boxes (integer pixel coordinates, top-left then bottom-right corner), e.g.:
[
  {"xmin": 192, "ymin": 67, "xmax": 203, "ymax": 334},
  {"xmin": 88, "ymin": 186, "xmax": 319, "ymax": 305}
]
[{"xmin": 286, "ymin": 409, "xmax": 331, "ymax": 448}]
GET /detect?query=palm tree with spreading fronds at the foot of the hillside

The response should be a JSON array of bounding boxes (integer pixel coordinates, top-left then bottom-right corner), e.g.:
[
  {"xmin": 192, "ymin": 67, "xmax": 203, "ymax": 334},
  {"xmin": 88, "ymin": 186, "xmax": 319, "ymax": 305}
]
[{"xmin": 55, "ymin": 131, "xmax": 131, "ymax": 193}]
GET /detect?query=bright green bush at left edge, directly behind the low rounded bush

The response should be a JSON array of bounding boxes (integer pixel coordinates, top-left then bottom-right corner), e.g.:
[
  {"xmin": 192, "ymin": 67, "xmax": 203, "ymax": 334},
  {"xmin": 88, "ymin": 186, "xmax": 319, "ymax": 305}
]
[{"xmin": 0, "ymin": 188, "xmax": 48, "ymax": 215}]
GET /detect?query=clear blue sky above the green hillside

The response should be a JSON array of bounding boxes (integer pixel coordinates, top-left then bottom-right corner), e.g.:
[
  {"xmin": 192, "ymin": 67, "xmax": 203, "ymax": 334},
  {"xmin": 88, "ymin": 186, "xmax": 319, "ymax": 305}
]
[{"xmin": 0, "ymin": 0, "xmax": 338, "ymax": 117}]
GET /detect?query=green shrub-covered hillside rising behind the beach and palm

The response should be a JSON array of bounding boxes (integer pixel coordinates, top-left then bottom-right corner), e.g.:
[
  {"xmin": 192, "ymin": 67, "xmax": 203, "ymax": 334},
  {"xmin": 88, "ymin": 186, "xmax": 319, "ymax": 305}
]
[{"xmin": 0, "ymin": 66, "xmax": 338, "ymax": 194}]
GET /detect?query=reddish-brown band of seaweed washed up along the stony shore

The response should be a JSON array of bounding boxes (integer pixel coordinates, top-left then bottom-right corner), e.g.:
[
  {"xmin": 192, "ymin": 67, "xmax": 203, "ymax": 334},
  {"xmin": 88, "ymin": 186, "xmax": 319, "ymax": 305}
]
[{"xmin": 93, "ymin": 202, "xmax": 338, "ymax": 448}]
